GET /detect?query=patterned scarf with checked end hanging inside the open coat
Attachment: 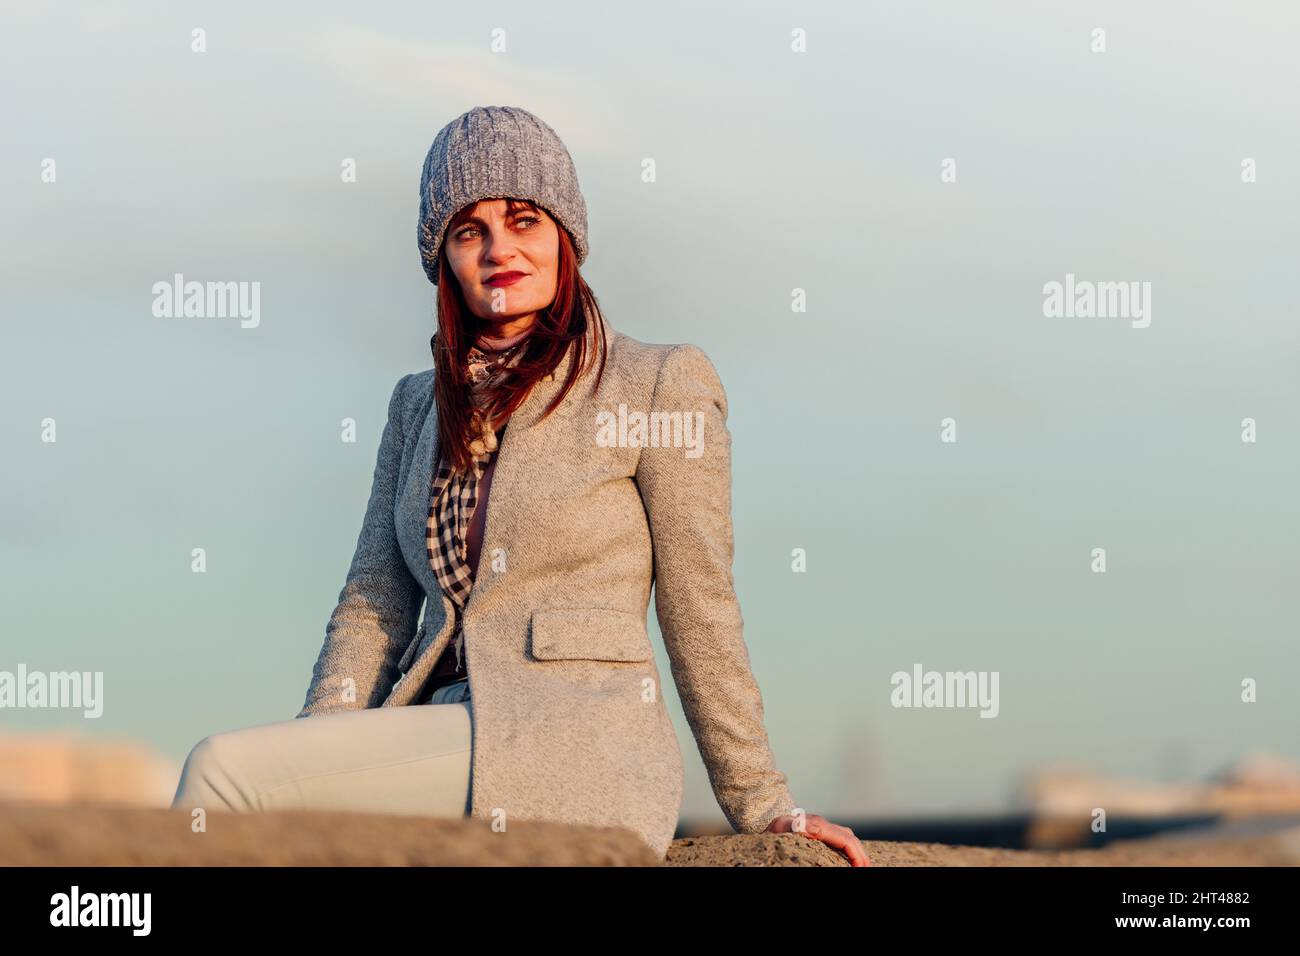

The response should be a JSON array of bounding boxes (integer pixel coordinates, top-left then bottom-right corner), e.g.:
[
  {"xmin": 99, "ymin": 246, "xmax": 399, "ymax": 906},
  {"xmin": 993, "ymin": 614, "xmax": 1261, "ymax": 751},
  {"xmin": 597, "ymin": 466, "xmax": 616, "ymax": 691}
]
[{"xmin": 425, "ymin": 336, "xmax": 528, "ymax": 674}]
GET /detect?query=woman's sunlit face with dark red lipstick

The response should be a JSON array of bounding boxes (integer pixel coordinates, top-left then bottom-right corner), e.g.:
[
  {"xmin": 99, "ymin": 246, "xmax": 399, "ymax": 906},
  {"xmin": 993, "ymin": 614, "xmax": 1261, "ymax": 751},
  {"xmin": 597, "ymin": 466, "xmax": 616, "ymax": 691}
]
[{"xmin": 445, "ymin": 199, "xmax": 560, "ymax": 337}]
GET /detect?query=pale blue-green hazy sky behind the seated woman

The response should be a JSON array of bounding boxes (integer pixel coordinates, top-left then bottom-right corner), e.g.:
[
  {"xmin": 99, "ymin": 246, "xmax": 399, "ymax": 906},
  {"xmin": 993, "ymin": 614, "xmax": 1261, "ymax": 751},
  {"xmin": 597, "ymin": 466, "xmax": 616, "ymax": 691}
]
[{"xmin": 0, "ymin": 1, "xmax": 1300, "ymax": 818}]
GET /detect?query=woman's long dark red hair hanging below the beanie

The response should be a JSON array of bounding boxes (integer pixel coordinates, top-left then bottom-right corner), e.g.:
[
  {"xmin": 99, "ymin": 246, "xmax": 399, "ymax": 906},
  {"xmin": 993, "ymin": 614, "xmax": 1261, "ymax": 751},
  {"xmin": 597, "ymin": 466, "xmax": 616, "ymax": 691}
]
[{"xmin": 429, "ymin": 199, "xmax": 608, "ymax": 472}]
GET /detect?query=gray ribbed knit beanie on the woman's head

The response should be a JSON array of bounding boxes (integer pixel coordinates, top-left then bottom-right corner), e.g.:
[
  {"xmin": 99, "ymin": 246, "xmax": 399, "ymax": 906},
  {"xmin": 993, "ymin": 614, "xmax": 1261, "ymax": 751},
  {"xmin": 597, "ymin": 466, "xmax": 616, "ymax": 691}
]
[{"xmin": 419, "ymin": 107, "xmax": 586, "ymax": 285}]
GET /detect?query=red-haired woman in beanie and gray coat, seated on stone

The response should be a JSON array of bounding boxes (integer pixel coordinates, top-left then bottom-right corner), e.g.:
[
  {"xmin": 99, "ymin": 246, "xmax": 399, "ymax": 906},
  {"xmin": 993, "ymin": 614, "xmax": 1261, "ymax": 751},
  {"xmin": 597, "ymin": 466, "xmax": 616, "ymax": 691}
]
[{"xmin": 173, "ymin": 107, "xmax": 867, "ymax": 865}]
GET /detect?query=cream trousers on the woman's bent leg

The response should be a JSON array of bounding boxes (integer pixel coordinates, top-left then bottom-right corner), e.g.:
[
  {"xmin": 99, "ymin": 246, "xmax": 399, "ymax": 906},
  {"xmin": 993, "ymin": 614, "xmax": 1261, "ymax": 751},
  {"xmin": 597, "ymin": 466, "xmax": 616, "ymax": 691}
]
[{"xmin": 172, "ymin": 680, "xmax": 473, "ymax": 817}]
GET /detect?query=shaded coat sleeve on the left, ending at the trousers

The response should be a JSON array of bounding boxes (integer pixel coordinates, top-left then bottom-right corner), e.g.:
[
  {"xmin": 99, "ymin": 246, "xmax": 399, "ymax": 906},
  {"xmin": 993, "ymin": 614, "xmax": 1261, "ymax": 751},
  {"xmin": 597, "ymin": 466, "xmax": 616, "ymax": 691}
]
[{"xmin": 296, "ymin": 375, "xmax": 424, "ymax": 717}]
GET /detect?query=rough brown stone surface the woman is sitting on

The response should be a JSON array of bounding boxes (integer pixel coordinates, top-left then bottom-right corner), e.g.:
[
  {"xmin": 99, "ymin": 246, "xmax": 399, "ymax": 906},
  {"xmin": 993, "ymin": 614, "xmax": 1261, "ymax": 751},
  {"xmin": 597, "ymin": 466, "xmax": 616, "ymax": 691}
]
[{"xmin": 0, "ymin": 803, "xmax": 1300, "ymax": 866}]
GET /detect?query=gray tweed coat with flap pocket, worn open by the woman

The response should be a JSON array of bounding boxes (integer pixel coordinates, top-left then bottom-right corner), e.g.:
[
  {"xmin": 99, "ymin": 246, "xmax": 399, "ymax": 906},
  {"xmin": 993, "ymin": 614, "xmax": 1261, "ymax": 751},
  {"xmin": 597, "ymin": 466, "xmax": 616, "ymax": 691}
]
[{"xmin": 298, "ymin": 319, "xmax": 796, "ymax": 857}]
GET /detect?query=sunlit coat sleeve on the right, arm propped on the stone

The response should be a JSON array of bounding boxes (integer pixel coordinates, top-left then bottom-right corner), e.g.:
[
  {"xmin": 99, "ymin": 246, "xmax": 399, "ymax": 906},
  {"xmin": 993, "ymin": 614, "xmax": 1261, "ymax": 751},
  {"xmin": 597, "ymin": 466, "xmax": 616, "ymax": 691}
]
[{"xmin": 636, "ymin": 345, "xmax": 796, "ymax": 834}]
